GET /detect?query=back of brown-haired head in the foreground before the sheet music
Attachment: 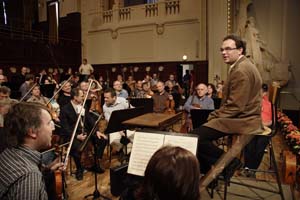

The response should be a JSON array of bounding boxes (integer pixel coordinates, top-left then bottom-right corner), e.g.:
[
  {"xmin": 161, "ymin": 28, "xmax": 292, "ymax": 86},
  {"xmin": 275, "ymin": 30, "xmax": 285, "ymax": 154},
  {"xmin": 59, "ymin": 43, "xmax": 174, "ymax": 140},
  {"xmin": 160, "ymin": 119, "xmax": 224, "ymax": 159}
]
[{"xmin": 135, "ymin": 146, "xmax": 200, "ymax": 200}]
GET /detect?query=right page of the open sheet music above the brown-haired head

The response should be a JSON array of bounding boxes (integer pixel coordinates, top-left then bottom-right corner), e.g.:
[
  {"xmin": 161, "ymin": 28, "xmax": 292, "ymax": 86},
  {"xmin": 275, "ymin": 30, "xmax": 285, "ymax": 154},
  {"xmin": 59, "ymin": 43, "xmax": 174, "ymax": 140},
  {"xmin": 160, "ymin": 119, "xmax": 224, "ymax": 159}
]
[{"xmin": 164, "ymin": 135, "xmax": 198, "ymax": 155}]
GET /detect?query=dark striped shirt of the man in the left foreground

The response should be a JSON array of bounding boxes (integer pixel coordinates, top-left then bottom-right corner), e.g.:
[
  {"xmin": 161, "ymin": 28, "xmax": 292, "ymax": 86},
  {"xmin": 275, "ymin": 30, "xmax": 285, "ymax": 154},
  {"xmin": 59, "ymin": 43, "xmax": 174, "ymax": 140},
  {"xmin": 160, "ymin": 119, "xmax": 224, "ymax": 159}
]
[{"xmin": 0, "ymin": 147, "xmax": 48, "ymax": 200}]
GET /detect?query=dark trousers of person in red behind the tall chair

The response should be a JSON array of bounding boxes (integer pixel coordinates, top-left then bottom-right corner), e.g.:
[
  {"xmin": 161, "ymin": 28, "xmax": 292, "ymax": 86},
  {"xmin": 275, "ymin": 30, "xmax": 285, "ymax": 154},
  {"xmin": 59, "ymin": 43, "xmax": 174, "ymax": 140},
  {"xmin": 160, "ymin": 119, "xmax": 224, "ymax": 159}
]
[{"xmin": 244, "ymin": 135, "xmax": 270, "ymax": 169}]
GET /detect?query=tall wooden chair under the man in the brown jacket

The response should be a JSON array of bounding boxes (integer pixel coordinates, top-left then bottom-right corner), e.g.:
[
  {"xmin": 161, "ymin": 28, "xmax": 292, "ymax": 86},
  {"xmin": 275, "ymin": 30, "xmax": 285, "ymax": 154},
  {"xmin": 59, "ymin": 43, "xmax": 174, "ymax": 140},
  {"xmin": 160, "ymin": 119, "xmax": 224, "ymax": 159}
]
[{"xmin": 202, "ymin": 84, "xmax": 284, "ymax": 200}]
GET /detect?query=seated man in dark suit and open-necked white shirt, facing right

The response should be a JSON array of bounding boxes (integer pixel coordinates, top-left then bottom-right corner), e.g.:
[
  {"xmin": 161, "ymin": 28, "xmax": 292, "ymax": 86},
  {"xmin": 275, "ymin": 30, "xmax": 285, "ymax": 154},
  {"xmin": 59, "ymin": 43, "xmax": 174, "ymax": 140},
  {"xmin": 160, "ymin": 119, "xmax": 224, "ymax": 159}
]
[{"xmin": 60, "ymin": 88, "xmax": 107, "ymax": 180}]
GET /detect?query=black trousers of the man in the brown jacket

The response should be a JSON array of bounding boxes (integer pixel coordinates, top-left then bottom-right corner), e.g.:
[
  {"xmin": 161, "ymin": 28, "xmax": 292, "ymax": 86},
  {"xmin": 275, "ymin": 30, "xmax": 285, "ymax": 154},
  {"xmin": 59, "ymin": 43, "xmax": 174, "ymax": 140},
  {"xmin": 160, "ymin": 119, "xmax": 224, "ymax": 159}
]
[{"xmin": 192, "ymin": 126, "xmax": 228, "ymax": 174}]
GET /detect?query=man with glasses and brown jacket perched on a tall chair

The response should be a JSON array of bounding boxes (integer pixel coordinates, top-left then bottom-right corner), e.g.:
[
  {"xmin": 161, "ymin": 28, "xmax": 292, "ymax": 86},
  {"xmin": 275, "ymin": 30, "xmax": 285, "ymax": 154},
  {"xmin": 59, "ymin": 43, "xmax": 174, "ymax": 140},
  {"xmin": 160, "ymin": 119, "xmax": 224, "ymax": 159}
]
[{"xmin": 193, "ymin": 35, "xmax": 263, "ymax": 185}]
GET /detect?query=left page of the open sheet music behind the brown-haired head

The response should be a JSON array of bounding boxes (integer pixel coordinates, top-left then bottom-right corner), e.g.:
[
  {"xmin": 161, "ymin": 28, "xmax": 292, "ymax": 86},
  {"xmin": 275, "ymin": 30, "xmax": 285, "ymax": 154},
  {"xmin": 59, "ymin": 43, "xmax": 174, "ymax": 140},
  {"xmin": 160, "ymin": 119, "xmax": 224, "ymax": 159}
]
[{"xmin": 127, "ymin": 132, "xmax": 165, "ymax": 176}]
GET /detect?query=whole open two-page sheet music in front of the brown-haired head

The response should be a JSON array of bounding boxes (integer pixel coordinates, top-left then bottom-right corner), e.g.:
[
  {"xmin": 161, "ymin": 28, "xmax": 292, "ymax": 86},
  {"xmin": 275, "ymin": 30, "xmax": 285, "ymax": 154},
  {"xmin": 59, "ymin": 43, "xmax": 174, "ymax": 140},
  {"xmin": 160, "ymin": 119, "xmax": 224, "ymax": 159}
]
[{"xmin": 127, "ymin": 132, "xmax": 198, "ymax": 176}]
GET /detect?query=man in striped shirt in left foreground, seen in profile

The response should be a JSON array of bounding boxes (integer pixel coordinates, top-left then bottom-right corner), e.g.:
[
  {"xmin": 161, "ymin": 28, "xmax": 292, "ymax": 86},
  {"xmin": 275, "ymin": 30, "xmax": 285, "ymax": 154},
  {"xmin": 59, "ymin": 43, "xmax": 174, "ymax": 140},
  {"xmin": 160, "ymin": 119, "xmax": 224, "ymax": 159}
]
[{"xmin": 0, "ymin": 102, "xmax": 63, "ymax": 200}]
